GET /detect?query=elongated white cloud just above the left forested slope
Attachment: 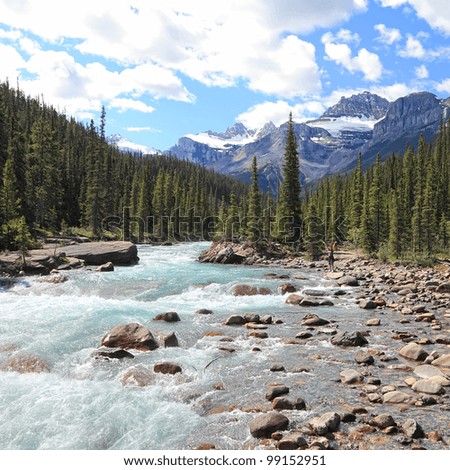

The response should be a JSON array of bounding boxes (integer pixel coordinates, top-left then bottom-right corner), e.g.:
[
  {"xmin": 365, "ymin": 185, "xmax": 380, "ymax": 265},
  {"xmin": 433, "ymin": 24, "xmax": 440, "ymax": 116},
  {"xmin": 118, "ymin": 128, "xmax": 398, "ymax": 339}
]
[{"xmin": 0, "ymin": 44, "xmax": 195, "ymax": 116}]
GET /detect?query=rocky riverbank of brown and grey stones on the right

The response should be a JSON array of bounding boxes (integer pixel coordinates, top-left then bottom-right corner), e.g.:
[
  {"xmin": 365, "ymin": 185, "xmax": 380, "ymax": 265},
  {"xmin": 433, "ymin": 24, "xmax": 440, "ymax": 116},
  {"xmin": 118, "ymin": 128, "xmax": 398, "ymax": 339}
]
[{"xmin": 200, "ymin": 243, "xmax": 450, "ymax": 449}]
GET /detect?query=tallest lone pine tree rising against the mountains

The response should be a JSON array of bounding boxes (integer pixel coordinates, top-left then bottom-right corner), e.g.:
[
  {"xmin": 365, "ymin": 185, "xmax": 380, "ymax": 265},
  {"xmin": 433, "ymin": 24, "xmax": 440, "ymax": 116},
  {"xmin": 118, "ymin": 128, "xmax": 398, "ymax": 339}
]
[{"xmin": 278, "ymin": 113, "xmax": 301, "ymax": 242}]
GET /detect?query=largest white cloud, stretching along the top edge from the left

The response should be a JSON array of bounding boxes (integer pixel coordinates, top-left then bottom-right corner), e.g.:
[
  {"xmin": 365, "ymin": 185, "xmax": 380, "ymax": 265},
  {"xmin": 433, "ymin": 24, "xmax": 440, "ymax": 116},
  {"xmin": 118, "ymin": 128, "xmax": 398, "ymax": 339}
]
[{"xmin": 0, "ymin": 0, "xmax": 368, "ymax": 101}]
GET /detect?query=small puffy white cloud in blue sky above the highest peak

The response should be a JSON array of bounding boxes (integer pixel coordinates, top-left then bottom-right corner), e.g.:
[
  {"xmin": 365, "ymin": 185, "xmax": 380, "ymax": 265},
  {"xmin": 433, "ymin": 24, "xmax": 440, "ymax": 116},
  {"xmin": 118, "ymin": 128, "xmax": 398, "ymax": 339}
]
[{"xmin": 322, "ymin": 33, "xmax": 383, "ymax": 81}]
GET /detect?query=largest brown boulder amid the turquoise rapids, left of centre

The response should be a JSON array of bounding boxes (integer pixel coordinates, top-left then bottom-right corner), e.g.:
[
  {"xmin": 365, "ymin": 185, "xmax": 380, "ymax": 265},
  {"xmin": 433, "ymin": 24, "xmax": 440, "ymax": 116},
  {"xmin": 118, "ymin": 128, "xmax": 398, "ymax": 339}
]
[{"xmin": 102, "ymin": 323, "xmax": 158, "ymax": 351}]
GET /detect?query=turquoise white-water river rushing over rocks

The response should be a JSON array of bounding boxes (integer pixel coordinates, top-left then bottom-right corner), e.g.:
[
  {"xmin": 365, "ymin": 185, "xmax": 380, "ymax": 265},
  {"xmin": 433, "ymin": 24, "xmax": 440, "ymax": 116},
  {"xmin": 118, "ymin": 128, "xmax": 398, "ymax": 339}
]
[{"xmin": 0, "ymin": 243, "xmax": 448, "ymax": 450}]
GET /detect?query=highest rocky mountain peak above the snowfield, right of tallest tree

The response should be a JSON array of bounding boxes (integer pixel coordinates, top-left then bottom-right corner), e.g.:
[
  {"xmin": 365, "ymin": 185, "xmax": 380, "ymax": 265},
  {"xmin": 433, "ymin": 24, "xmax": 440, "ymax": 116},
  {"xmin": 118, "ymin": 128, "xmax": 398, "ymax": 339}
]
[{"xmin": 322, "ymin": 91, "xmax": 389, "ymax": 120}]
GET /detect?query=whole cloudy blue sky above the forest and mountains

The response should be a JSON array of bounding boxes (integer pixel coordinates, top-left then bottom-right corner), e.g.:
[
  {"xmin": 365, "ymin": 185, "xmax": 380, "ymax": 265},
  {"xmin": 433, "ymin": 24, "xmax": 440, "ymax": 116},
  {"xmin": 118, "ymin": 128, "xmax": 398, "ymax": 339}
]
[{"xmin": 0, "ymin": 0, "xmax": 450, "ymax": 150}]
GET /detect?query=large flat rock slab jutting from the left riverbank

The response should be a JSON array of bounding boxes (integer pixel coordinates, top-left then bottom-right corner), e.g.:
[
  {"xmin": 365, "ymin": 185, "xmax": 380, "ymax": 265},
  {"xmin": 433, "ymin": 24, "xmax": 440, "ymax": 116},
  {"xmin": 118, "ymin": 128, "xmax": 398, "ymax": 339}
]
[{"xmin": 30, "ymin": 241, "xmax": 138, "ymax": 266}]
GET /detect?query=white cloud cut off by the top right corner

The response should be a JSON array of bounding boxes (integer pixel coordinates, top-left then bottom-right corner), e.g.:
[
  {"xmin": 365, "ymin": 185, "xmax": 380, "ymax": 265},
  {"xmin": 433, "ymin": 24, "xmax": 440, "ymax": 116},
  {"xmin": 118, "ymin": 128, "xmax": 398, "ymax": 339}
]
[{"xmin": 379, "ymin": 0, "xmax": 450, "ymax": 35}]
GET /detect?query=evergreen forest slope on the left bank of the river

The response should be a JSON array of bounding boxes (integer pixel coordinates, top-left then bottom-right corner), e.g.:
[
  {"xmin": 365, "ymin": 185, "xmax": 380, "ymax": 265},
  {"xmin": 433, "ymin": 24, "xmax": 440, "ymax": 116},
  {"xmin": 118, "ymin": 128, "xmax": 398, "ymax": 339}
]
[{"xmin": 0, "ymin": 82, "xmax": 248, "ymax": 249}]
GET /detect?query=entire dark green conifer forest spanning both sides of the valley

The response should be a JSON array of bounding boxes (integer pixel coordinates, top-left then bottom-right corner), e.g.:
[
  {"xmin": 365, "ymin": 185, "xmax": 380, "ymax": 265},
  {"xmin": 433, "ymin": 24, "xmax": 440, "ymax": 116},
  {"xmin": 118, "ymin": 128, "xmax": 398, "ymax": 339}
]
[{"xmin": 0, "ymin": 83, "xmax": 450, "ymax": 260}]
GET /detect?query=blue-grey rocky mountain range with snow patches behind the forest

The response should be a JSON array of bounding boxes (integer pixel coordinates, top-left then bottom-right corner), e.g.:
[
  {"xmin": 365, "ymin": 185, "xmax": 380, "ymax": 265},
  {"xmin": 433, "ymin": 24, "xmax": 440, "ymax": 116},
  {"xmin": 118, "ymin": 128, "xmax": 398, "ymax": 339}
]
[{"xmin": 110, "ymin": 91, "xmax": 450, "ymax": 193}]
